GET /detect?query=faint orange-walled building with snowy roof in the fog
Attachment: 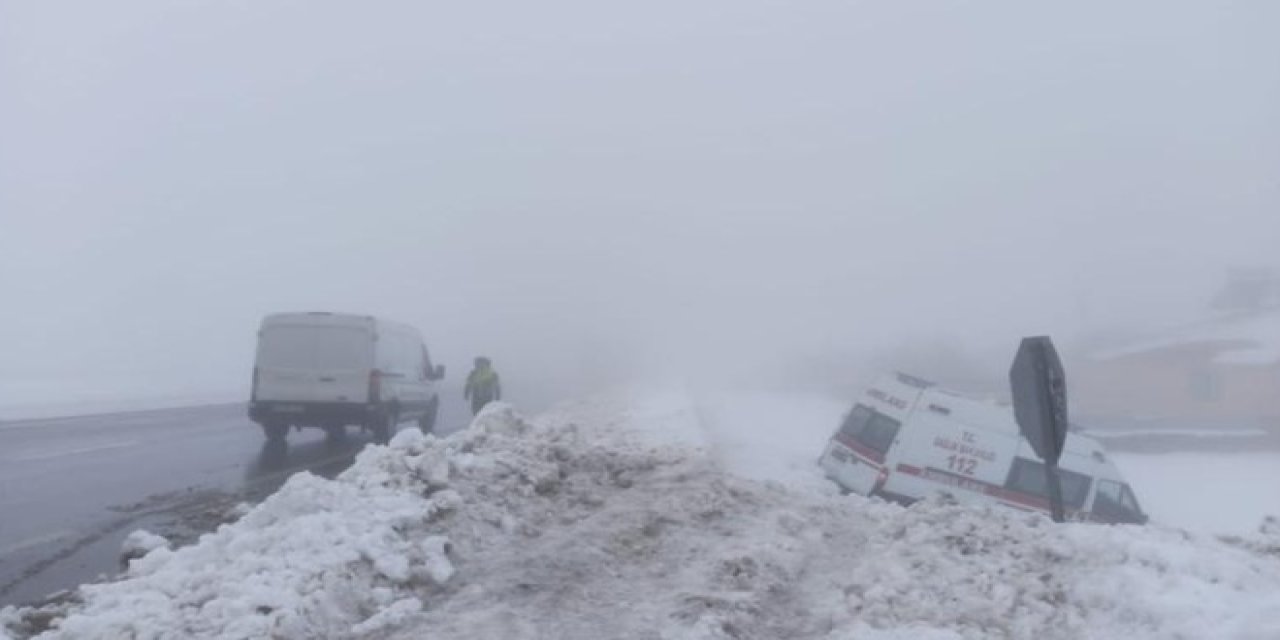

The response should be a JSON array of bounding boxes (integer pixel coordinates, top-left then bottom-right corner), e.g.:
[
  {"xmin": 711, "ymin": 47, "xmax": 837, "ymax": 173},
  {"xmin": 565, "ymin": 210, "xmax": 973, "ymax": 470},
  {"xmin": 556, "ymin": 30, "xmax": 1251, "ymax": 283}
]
[{"xmin": 1073, "ymin": 269, "xmax": 1280, "ymax": 429}]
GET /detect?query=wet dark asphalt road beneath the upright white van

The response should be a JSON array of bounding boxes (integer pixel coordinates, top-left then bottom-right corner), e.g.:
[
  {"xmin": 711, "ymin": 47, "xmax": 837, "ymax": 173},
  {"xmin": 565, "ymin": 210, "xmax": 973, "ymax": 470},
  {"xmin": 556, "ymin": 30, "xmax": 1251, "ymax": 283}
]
[{"xmin": 0, "ymin": 396, "xmax": 470, "ymax": 607}]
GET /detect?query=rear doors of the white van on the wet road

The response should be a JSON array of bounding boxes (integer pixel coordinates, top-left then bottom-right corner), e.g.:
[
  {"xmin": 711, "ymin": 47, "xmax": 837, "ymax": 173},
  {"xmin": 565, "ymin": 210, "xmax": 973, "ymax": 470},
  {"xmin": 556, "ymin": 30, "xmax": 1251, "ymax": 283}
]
[{"xmin": 256, "ymin": 324, "xmax": 374, "ymax": 403}]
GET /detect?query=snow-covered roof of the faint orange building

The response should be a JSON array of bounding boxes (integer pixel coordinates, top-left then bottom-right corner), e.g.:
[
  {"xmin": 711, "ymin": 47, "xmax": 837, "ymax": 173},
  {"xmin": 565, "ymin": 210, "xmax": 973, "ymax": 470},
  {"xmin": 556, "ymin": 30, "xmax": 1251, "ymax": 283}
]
[{"xmin": 1094, "ymin": 308, "xmax": 1280, "ymax": 365}]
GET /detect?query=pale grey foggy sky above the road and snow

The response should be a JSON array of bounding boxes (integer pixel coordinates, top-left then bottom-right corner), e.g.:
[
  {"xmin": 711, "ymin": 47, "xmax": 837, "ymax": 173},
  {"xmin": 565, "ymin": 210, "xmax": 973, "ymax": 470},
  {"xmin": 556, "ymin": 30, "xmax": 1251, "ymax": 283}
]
[{"xmin": 0, "ymin": 0, "xmax": 1280, "ymax": 404}]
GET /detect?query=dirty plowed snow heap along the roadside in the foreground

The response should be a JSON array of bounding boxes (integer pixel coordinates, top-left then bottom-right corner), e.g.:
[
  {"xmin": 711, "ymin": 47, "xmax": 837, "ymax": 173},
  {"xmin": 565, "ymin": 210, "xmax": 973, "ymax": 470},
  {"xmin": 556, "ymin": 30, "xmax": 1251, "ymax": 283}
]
[{"xmin": 0, "ymin": 396, "xmax": 1280, "ymax": 640}]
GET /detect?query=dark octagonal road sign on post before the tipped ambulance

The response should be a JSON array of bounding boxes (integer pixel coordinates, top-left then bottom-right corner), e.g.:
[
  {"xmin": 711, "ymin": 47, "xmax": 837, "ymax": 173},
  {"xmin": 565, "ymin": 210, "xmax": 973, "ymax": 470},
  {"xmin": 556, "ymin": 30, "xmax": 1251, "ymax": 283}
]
[{"xmin": 1009, "ymin": 335, "xmax": 1068, "ymax": 522}]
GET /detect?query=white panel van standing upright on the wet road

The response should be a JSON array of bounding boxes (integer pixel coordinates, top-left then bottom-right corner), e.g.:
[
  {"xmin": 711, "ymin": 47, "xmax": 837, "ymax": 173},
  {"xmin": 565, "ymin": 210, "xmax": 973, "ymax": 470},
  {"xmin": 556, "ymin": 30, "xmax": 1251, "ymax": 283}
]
[{"xmin": 248, "ymin": 311, "xmax": 444, "ymax": 443}]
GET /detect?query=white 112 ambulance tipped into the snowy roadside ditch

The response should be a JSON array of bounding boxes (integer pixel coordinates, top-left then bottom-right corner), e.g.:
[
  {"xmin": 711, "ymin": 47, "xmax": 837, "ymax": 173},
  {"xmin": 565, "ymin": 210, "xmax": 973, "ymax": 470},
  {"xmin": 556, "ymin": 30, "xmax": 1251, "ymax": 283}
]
[{"xmin": 819, "ymin": 374, "xmax": 1147, "ymax": 524}]
